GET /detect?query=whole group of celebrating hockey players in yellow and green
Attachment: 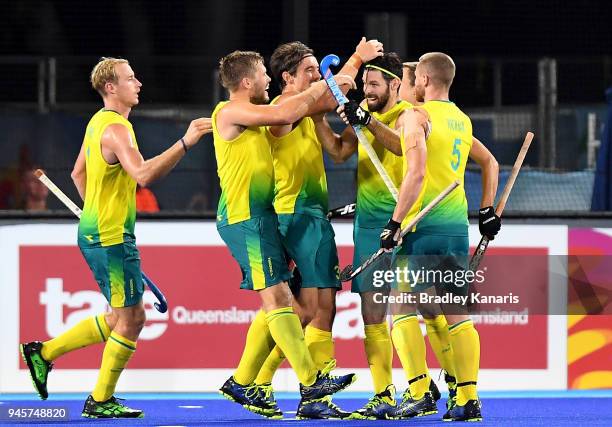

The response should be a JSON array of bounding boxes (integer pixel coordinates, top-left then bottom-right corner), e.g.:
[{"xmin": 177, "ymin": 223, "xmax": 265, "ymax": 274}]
[{"xmin": 21, "ymin": 38, "xmax": 501, "ymax": 421}]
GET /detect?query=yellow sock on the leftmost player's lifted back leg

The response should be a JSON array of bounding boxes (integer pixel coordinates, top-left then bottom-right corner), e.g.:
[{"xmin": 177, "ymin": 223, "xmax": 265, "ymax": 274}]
[{"xmin": 41, "ymin": 314, "xmax": 110, "ymax": 362}]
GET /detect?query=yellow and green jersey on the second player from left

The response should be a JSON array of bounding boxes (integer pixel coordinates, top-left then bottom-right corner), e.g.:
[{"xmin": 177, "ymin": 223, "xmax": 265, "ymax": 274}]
[{"xmin": 212, "ymin": 101, "xmax": 274, "ymax": 227}]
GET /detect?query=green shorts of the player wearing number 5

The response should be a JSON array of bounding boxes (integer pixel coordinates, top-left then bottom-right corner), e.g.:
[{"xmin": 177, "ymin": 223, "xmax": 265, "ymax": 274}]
[{"xmin": 393, "ymin": 232, "xmax": 473, "ymax": 295}]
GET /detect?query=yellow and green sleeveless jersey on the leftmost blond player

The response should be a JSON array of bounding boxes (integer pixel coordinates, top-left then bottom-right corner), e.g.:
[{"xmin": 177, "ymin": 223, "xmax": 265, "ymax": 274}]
[{"xmin": 78, "ymin": 109, "xmax": 138, "ymax": 246}]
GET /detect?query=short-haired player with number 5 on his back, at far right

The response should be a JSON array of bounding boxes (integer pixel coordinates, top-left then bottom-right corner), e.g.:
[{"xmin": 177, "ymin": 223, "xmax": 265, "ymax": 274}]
[{"xmin": 381, "ymin": 52, "xmax": 501, "ymax": 421}]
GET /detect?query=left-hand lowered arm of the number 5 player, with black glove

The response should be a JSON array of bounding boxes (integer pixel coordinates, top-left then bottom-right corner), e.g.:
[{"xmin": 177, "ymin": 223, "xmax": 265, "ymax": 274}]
[{"xmin": 380, "ymin": 110, "xmax": 428, "ymax": 250}]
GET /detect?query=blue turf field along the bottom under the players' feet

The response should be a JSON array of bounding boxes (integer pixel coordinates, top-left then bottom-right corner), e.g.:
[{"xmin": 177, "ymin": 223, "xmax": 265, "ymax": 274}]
[{"xmin": 0, "ymin": 390, "xmax": 612, "ymax": 427}]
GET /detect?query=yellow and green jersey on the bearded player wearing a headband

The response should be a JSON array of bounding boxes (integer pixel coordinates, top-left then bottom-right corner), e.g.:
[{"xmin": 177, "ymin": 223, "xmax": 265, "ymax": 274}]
[{"xmin": 355, "ymin": 101, "xmax": 412, "ymax": 228}]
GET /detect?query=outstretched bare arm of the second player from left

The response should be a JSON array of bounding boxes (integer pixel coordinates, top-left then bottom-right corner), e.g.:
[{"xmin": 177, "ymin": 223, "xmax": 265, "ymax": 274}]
[{"xmin": 217, "ymin": 75, "xmax": 356, "ymax": 140}]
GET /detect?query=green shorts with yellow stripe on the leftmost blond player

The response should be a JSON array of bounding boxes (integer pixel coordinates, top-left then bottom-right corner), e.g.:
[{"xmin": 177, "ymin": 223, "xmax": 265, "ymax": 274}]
[{"xmin": 79, "ymin": 241, "xmax": 144, "ymax": 307}]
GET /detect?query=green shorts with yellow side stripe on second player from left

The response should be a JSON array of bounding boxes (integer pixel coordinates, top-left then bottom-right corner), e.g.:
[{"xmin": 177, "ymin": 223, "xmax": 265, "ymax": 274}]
[{"xmin": 217, "ymin": 214, "xmax": 291, "ymax": 291}]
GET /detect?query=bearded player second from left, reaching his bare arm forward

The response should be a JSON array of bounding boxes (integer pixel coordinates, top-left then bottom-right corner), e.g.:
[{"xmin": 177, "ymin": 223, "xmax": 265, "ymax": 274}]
[{"xmin": 212, "ymin": 51, "xmax": 355, "ymax": 418}]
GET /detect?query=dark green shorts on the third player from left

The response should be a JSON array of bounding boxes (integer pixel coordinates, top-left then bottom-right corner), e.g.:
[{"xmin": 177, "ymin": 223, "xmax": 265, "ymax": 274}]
[{"xmin": 278, "ymin": 214, "xmax": 341, "ymax": 288}]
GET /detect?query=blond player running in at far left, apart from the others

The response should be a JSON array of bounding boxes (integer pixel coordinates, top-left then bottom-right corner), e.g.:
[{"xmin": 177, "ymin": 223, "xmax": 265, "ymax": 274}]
[{"xmin": 21, "ymin": 58, "xmax": 212, "ymax": 418}]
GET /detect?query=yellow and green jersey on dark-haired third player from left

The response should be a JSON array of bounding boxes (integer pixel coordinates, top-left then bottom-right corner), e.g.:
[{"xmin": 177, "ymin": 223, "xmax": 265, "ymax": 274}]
[{"xmin": 268, "ymin": 98, "xmax": 328, "ymax": 218}]
